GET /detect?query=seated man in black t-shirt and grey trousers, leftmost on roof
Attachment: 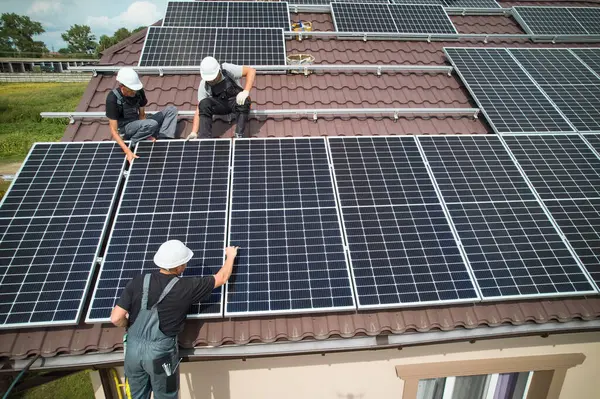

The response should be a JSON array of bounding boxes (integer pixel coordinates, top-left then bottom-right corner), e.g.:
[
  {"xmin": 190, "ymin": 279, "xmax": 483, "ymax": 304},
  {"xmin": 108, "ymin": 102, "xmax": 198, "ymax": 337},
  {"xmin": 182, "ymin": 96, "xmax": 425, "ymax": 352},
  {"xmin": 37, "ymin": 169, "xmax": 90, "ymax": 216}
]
[{"xmin": 106, "ymin": 68, "xmax": 177, "ymax": 162}]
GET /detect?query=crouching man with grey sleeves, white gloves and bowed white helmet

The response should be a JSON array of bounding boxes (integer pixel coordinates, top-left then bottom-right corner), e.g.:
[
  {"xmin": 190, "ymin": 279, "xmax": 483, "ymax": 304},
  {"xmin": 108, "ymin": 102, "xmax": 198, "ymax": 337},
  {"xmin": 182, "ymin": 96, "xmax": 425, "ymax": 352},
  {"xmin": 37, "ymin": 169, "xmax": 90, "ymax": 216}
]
[{"xmin": 188, "ymin": 57, "xmax": 256, "ymax": 139}]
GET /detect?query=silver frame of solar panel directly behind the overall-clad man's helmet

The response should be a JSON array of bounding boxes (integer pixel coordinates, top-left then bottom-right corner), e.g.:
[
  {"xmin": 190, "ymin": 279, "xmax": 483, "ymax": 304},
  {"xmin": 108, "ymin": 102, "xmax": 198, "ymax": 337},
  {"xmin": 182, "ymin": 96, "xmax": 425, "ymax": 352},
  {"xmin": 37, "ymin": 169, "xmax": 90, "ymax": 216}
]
[{"xmin": 85, "ymin": 138, "xmax": 233, "ymax": 324}]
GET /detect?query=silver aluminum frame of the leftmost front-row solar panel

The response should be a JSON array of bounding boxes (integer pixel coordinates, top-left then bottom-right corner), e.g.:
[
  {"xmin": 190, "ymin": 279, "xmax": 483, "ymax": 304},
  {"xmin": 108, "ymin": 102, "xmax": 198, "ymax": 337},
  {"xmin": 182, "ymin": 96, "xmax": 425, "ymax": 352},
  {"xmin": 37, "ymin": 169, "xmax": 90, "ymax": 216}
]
[{"xmin": 0, "ymin": 141, "xmax": 127, "ymax": 330}]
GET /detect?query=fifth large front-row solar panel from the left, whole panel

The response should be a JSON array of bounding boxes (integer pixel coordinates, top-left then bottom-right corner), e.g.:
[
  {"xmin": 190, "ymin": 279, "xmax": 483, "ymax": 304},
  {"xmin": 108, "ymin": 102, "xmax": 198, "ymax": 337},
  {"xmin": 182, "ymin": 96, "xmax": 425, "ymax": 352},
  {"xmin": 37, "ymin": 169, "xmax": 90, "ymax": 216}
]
[{"xmin": 419, "ymin": 136, "xmax": 595, "ymax": 300}]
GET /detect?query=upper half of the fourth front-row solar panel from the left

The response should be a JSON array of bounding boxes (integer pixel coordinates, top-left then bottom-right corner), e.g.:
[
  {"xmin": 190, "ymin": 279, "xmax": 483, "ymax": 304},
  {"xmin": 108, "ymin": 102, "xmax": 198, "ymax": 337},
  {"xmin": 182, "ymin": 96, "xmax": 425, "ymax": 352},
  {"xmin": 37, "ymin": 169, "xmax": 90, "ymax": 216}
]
[{"xmin": 329, "ymin": 137, "xmax": 439, "ymax": 207}]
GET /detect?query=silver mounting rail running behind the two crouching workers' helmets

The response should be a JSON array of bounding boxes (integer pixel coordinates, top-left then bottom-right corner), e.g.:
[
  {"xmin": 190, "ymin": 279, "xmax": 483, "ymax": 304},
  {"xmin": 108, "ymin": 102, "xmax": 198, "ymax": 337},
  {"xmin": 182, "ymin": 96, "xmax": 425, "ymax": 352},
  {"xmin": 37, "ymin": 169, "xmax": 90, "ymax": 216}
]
[{"xmin": 69, "ymin": 64, "xmax": 453, "ymax": 76}]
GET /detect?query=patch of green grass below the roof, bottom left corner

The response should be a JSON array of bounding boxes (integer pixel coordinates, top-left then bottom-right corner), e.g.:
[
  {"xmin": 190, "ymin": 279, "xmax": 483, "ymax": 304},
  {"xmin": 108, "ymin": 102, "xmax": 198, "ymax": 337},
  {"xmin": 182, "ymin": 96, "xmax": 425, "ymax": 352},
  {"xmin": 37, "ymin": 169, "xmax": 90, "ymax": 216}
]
[{"xmin": 10, "ymin": 371, "xmax": 94, "ymax": 399}]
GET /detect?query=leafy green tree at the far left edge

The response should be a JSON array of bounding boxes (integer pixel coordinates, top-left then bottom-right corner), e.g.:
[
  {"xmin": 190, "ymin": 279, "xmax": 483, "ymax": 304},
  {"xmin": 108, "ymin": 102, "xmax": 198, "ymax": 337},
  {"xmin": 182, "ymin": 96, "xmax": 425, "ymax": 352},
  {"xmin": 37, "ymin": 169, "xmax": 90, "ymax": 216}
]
[{"xmin": 0, "ymin": 13, "xmax": 48, "ymax": 57}]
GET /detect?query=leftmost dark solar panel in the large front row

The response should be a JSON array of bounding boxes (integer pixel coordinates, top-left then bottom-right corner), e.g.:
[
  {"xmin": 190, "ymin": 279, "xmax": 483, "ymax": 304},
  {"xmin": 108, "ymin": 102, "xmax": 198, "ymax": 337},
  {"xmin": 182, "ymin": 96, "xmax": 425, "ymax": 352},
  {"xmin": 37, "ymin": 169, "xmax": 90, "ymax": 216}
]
[{"xmin": 0, "ymin": 143, "xmax": 125, "ymax": 328}]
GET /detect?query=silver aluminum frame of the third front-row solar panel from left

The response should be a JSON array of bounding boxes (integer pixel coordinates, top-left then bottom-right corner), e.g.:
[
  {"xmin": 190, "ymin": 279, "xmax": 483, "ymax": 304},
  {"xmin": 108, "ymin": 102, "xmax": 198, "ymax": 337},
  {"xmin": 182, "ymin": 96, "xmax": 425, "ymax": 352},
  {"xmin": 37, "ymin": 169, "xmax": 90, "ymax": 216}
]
[{"xmin": 224, "ymin": 137, "xmax": 357, "ymax": 317}]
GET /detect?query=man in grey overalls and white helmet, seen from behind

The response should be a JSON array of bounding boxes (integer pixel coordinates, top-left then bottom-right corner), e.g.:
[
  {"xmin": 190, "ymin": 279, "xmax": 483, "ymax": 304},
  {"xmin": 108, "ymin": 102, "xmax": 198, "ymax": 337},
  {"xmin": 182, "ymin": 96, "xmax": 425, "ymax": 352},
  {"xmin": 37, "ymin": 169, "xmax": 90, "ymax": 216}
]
[{"xmin": 110, "ymin": 240, "xmax": 238, "ymax": 399}]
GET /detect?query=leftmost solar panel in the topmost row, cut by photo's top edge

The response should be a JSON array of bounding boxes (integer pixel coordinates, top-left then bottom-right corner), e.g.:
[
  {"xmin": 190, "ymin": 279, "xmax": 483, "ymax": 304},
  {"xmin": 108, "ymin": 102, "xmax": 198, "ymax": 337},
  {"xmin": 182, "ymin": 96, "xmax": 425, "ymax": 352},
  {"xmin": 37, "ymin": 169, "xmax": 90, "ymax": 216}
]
[{"xmin": 162, "ymin": 1, "xmax": 229, "ymax": 28}]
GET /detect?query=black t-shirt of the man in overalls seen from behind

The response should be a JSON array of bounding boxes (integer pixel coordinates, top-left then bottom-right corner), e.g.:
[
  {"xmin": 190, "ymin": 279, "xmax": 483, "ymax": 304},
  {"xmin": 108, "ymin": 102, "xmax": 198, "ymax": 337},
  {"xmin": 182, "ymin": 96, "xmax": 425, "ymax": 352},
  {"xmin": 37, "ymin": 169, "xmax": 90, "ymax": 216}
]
[{"xmin": 117, "ymin": 272, "xmax": 215, "ymax": 337}]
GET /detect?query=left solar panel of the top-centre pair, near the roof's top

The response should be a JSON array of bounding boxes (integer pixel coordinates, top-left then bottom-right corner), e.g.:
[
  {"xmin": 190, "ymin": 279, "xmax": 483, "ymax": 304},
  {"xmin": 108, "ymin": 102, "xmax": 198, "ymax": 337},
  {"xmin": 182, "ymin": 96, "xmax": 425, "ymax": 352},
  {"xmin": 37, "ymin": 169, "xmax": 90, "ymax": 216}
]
[{"xmin": 331, "ymin": 3, "xmax": 398, "ymax": 32}]
